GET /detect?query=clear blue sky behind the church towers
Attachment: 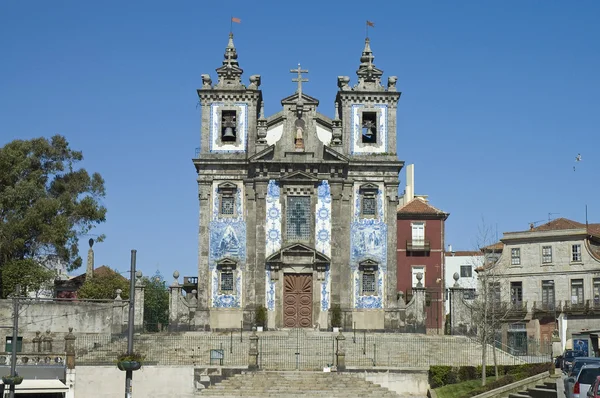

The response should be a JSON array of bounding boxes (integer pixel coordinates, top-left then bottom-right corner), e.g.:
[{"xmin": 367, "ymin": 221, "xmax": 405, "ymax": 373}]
[{"xmin": 0, "ymin": 0, "xmax": 600, "ymax": 281}]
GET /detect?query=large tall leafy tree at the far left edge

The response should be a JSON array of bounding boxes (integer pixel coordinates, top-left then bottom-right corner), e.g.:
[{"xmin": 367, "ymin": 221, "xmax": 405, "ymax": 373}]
[{"xmin": 0, "ymin": 135, "xmax": 106, "ymax": 297}]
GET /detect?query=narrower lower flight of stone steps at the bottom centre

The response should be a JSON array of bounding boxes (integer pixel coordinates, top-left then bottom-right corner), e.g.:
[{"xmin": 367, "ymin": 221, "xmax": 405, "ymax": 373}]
[{"xmin": 200, "ymin": 372, "xmax": 408, "ymax": 398}]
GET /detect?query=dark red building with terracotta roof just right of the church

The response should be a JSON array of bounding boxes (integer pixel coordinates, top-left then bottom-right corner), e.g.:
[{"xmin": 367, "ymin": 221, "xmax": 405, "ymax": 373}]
[{"xmin": 396, "ymin": 165, "xmax": 449, "ymax": 334}]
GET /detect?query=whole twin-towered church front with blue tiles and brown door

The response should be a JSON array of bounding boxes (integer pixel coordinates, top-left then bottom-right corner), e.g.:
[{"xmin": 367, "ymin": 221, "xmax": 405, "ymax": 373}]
[{"xmin": 193, "ymin": 34, "xmax": 404, "ymax": 330}]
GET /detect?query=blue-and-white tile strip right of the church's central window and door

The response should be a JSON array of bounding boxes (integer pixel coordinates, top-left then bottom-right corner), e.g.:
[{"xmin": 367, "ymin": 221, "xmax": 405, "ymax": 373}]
[{"xmin": 315, "ymin": 180, "xmax": 331, "ymax": 311}]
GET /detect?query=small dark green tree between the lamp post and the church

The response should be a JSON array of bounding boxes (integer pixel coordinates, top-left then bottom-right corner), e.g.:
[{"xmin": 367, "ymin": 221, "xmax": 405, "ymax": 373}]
[{"xmin": 142, "ymin": 274, "xmax": 169, "ymax": 332}]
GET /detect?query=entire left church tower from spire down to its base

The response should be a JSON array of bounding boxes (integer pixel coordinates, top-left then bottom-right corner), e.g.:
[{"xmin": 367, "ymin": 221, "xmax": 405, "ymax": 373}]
[{"xmin": 194, "ymin": 33, "xmax": 262, "ymax": 328}]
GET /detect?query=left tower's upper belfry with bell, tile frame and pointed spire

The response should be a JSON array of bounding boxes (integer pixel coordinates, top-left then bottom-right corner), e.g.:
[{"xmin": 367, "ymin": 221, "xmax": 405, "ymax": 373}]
[{"xmin": 198, "ymin": 33, "xmax": 262, "ymax": 154}]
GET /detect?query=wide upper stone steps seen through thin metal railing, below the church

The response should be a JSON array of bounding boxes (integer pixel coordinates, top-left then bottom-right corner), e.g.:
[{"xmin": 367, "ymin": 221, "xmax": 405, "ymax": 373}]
[{"xmin": 76, "ymin": 329, "xmax": 551, "ymax": 370}]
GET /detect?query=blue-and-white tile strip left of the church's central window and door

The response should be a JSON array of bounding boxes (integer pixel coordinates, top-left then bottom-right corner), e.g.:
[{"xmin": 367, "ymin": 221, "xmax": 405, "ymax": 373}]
[{"xmin": 265, "ymin": 180, "xmax": 282, "ymax": 311}]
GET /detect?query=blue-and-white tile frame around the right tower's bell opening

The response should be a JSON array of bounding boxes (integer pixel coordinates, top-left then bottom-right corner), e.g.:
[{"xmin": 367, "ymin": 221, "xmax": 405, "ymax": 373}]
[{"xmin": 350, "ymin": 104, "xmax": 388, "ymax": 155}]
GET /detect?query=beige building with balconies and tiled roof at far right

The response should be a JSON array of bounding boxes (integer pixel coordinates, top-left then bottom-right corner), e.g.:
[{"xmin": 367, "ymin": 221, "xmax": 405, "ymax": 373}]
[{"xmin": 486, "ymin": 218, "xmax": 600, "ymax": 352}]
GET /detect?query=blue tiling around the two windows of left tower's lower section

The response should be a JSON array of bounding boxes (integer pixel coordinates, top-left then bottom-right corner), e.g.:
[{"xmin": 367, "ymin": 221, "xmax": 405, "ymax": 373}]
[{"xmin": 208, "ymin": 181, "xmax": 246, "ymax": 308}]
